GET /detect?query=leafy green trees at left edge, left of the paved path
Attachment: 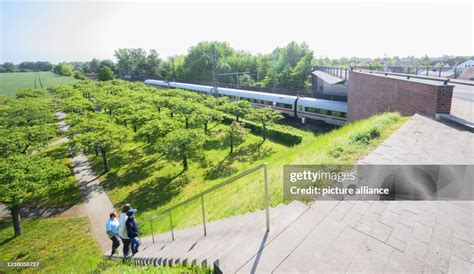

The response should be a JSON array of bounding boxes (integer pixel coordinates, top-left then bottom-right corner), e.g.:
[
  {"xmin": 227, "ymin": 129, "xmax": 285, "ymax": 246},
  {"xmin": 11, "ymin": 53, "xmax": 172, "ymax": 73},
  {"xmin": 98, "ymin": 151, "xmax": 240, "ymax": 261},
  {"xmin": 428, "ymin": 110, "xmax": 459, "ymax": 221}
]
[{"xmin": 0, "ymin": 89, "xmax": 70, "ymax": 236}]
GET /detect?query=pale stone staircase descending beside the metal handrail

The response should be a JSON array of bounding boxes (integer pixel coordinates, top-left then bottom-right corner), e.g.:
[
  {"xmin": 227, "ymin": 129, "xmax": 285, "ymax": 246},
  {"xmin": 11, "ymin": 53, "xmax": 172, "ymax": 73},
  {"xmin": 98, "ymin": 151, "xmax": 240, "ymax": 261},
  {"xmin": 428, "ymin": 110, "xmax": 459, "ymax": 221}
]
[{"xmin": 106, "ymin": 201, "xmax": 309, "ymax": 273}]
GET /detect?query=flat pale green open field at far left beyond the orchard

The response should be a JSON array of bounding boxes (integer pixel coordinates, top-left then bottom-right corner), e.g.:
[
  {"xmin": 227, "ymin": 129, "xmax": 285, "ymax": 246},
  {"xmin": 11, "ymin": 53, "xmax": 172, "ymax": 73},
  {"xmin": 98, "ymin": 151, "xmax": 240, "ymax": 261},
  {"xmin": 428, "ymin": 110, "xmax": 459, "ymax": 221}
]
[{"xmin": 0, "ymin": 71, "xmax": 79, "ymax": 97}]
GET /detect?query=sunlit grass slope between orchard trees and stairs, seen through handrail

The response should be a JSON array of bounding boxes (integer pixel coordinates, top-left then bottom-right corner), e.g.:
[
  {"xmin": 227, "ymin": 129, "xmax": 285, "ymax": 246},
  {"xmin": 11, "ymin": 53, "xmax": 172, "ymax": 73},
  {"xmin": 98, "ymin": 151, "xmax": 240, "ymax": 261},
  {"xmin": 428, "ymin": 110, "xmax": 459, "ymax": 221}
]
[{"xmin": 89, "ymin": 113, "xmax": 406, "ymax": 234}]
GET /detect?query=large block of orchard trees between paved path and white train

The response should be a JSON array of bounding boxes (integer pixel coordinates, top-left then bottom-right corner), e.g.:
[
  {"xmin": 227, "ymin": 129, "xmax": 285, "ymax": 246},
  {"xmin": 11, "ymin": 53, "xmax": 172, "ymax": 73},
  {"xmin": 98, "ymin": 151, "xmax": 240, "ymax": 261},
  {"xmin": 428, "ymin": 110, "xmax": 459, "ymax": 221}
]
[{"xmin": 50, "ymin": 80, "xmax": 283, "ymax": 172}]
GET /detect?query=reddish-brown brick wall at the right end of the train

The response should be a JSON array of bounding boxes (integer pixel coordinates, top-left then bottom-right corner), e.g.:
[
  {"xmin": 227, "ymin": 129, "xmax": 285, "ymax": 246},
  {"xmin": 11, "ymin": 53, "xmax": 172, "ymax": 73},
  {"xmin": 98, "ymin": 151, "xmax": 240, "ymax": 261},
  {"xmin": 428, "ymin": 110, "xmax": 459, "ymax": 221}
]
[{"xmin": 347, "ymin": 71, "xmax": 454, "ymax": 122}]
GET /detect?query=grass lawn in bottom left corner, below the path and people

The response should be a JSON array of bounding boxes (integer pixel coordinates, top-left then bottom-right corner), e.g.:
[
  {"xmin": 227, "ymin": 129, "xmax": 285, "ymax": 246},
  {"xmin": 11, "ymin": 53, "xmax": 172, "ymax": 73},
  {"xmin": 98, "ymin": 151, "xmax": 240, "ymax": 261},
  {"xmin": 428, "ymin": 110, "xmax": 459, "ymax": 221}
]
[{"xmin": 0, "ymin": 217, "xmax": 211, "ymax": 273}]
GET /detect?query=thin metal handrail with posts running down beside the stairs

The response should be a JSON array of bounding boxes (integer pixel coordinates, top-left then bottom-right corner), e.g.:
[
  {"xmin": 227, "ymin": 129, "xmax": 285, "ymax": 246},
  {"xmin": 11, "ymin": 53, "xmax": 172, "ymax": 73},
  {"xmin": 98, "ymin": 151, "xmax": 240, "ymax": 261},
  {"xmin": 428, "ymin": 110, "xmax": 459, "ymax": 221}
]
[{"xmin": 140, "ymin": 163, "xmax": 270, "ymax": 243}]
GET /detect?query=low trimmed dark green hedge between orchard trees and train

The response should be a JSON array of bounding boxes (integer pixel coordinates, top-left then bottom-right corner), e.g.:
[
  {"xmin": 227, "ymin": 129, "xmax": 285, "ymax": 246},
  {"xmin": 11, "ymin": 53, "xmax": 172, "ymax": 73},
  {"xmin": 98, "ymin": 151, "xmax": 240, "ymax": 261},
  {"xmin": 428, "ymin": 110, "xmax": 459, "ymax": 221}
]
[{"xmin": 223, "ymin": 115, "xmax": 303, "ymax": 146}]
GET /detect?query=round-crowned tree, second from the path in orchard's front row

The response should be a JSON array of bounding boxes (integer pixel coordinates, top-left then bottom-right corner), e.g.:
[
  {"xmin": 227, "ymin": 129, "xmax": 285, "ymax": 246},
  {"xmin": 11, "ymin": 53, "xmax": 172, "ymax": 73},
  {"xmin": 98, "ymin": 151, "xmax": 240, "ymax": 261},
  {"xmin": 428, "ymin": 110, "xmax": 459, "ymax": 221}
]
[{"xmin": 158, "ymin": 129, "xmax": 206, "ymax": 171}]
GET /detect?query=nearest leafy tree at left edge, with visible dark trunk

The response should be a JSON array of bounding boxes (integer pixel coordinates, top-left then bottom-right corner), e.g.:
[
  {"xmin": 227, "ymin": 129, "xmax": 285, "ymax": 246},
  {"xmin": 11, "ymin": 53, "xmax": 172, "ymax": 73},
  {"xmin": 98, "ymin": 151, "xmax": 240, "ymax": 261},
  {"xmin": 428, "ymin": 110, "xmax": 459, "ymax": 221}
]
[{"xmin": 0, "ymin": 154, "xmax": 70, "ymax": 236}]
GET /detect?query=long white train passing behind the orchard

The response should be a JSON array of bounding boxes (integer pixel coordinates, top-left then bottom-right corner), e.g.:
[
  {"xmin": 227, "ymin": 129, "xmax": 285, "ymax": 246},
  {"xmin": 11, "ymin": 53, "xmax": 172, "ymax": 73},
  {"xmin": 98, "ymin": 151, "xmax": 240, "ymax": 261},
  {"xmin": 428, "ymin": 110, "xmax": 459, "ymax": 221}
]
[{"xmin": 145, "ymin": 79, "xmax": 347, "ymax": 125}]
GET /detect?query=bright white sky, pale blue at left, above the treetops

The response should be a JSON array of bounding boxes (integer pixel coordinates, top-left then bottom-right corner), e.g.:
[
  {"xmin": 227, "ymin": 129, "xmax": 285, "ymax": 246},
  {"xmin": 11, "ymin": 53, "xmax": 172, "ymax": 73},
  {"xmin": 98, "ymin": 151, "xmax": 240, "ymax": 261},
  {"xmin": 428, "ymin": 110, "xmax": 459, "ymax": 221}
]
[{"xmin": 0, "ymin": 0, "xmax": 474, "ymax": 63}]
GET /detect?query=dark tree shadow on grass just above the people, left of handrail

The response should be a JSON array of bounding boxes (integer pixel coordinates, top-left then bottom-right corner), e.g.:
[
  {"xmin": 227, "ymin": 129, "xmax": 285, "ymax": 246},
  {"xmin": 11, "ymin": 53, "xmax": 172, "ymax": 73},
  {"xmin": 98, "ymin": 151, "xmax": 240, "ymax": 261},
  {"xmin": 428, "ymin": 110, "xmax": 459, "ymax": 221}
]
[{"xmin": 124, "ymin": 171, "xmax": 190, "ymax": 211}]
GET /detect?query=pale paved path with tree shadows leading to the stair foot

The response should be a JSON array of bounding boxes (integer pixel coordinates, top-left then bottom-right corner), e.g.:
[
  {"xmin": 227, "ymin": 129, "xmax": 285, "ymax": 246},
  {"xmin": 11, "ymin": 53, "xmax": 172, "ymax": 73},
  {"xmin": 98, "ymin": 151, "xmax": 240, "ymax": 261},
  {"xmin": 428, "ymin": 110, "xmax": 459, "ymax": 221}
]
[{"xmin": 56, "ymin": 112, "xmax": 114, "ymax": 250}]
